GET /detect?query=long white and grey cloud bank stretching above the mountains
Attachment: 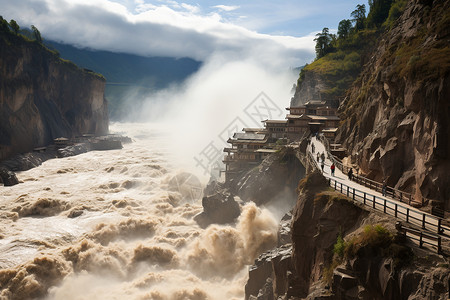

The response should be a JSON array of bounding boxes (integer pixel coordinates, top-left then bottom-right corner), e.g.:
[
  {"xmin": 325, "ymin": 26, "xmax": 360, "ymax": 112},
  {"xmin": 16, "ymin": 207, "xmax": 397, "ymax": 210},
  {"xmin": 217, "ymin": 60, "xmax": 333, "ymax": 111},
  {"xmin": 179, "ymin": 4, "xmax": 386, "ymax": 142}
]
[{"xmin": 0, "ymin": 0, "xmax": 314, "ymax": 67}]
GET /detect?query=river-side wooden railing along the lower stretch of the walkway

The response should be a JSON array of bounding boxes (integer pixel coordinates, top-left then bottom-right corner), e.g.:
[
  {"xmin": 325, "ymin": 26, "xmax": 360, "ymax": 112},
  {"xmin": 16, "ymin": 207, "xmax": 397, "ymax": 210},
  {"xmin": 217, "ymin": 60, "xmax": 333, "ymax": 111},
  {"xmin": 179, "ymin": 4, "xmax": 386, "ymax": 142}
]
[{"xmin": 328, "ymin": 178, "xmax": 450, "ymax": 239}]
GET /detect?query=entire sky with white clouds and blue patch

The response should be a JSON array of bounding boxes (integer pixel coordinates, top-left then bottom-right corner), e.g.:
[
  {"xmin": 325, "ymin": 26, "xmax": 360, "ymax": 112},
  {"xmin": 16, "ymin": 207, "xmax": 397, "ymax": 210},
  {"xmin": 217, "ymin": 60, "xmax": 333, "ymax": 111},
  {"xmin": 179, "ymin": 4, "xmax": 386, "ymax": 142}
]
[{"xmin": 0, "ymin": 0, "xmax": 367, "ymax": 67}]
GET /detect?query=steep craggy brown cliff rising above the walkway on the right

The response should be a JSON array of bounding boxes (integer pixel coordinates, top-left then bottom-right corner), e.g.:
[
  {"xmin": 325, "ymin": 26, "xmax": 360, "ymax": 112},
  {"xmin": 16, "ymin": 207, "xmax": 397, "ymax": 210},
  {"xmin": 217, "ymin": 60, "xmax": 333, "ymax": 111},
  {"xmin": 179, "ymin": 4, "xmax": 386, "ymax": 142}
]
[{"xmin": 338, "ymin": 0, "xmax": 450, "ymax": 210}]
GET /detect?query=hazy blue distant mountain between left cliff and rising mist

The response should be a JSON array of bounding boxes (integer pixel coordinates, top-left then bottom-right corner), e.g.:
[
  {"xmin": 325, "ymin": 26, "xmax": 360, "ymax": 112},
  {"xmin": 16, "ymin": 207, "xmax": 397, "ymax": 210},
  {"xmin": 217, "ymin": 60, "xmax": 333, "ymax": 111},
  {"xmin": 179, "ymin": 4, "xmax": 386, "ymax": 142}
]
[{"xmin": 45, "ymin": 40, "xmax": 202, "ymax": 120}]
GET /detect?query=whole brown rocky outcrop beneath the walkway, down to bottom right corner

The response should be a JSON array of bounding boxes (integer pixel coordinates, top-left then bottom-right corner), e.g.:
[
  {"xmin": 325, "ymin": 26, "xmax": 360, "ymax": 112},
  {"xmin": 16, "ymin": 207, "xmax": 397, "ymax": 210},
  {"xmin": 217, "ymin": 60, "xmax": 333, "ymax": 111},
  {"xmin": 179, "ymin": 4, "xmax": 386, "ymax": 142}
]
[{"xmin": 245, "ymin": 173, "xmax": 450, "ymax": 300}]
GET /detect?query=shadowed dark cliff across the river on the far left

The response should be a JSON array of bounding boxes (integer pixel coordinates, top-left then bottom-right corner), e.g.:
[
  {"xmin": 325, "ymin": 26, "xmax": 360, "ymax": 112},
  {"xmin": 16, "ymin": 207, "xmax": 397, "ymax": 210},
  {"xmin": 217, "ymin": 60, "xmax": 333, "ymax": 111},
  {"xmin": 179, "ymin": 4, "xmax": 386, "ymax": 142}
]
[{"xmin": 0, "ymin": 31, "xmax": 108, "ymax": 160}]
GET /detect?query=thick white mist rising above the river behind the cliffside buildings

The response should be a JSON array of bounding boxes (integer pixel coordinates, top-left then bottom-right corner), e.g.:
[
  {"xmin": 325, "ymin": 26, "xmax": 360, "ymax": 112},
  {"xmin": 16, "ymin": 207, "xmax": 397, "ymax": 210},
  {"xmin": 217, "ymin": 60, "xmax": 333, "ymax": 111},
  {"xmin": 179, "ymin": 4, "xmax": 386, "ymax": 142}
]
[{"xmin": 114, "ymin": 53, "xmax": 298, "ymax": 181}]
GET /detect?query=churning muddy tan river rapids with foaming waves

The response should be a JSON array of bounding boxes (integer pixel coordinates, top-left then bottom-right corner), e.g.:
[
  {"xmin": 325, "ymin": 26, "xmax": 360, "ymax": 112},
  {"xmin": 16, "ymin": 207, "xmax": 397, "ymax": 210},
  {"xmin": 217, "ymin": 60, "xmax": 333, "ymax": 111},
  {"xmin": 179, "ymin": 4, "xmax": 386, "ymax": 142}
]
[{"xmin": 0, "ymin": 124, "xmax": 277, "ymax": 300}]
